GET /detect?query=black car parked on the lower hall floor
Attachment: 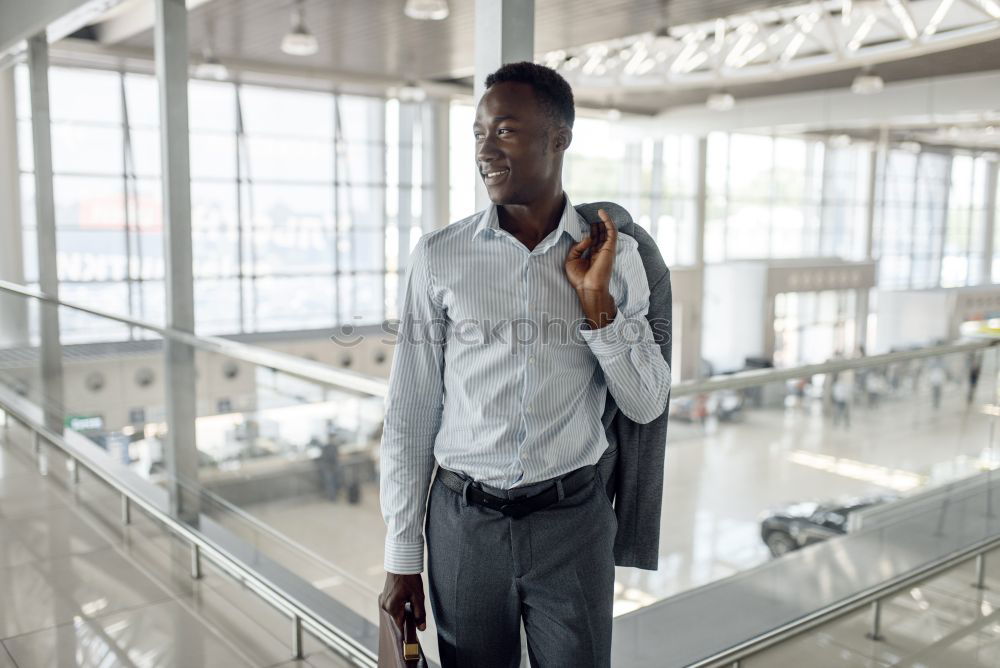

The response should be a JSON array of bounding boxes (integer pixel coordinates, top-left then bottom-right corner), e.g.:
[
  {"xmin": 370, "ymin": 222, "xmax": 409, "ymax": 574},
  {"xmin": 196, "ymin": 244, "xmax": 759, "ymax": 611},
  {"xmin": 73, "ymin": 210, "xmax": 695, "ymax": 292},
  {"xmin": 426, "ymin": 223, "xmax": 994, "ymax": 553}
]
[{"xmin": 760, "ymin": 494, "xmax": 897, "ymax": 557}]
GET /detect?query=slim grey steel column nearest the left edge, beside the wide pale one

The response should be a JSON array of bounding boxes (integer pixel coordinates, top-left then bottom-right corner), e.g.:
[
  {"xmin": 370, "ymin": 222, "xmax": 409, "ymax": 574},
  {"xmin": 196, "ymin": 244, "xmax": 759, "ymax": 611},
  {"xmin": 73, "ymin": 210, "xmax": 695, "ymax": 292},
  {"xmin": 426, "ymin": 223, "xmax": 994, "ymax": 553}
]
[{"xmin": 28, "ymin": 32, "xmax": 63, "ymax": 433}]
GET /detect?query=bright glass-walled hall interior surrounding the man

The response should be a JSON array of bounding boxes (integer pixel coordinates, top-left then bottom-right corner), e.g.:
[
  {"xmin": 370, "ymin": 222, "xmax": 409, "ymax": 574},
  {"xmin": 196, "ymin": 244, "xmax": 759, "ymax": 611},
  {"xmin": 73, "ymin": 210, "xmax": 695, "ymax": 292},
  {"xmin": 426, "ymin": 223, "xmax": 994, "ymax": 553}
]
[{"xmin": 0, "ymin": 0, "xmax": 1000, "ymax": 668}]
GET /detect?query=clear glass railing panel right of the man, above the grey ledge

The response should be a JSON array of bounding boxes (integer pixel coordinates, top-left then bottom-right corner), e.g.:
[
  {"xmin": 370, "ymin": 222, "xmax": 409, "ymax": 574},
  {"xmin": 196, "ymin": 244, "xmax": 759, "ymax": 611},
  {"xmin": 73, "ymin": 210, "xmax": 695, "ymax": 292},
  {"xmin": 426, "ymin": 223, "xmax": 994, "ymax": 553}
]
[{"xmin": 632, "ymin": 342, "xmax": 998, "ymax": 613}]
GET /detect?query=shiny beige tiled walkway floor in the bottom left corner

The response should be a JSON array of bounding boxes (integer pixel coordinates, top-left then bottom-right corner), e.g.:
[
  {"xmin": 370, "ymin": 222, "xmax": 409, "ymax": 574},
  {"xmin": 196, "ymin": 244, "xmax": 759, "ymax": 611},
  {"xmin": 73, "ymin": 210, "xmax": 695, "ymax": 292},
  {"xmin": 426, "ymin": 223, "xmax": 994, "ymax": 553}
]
[{"xmin": 0, "ymin": 432, "xmax": 347, "ymax": 668}]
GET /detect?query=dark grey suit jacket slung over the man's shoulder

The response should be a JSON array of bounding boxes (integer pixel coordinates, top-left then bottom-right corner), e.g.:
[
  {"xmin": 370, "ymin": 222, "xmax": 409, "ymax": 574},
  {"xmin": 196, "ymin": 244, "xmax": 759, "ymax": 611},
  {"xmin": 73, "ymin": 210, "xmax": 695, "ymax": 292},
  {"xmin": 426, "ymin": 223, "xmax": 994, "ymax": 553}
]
[{"xmin": 576, "ymin": 202, "xmax": 673, "ymax": 570}]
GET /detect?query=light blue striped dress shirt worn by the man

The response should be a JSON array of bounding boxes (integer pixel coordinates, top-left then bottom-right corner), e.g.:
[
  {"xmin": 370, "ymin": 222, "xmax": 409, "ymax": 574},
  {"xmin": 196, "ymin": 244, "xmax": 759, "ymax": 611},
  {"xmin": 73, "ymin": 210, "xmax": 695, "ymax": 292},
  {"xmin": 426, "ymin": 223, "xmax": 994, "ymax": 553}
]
[{"xmin": 380, "ymin": 197, "xmax": 670, "ymax": 573}]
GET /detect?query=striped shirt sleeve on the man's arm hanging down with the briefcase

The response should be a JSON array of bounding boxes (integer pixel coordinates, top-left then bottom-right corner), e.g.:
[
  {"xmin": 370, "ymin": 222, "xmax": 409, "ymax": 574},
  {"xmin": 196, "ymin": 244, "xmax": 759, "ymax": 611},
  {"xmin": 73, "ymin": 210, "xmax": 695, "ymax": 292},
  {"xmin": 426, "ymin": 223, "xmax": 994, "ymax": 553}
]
[{"xmin": 379, "ymin": 235, "xmax": 445, "ymax": 574}]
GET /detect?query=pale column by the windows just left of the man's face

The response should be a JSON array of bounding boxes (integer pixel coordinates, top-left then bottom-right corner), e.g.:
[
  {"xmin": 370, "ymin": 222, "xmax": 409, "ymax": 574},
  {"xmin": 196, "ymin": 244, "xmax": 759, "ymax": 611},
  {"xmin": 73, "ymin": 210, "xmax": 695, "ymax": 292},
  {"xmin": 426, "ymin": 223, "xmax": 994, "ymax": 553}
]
[{"xmin": 422, "ymin": 99, "xmax": 450, "ymax": 232}]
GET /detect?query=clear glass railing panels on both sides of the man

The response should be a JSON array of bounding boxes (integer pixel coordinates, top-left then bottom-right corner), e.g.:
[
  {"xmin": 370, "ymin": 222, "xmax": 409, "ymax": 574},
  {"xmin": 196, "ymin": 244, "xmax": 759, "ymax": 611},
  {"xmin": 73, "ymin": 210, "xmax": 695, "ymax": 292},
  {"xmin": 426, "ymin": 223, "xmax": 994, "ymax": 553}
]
[{"xmin": 7, "ymin": 276, "xmax": 1000, "ymax": 659}]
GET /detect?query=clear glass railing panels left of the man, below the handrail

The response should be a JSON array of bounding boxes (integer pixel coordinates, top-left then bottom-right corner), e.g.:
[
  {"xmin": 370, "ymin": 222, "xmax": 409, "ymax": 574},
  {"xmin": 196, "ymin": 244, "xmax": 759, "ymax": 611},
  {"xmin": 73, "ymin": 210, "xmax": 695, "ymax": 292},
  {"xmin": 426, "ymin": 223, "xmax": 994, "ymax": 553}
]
[{"xmin": 0, "ymin": 284, "xmax": 385, "ymax": 664}]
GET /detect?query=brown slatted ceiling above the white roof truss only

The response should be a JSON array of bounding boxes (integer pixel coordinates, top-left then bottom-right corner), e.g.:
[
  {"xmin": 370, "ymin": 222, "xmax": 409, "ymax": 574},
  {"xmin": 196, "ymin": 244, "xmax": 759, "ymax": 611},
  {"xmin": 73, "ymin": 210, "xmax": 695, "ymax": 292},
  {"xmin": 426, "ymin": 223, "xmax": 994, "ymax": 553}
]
[{"xmin": 98, "ymin": 0, "xmax": 788, "ymax": 85}]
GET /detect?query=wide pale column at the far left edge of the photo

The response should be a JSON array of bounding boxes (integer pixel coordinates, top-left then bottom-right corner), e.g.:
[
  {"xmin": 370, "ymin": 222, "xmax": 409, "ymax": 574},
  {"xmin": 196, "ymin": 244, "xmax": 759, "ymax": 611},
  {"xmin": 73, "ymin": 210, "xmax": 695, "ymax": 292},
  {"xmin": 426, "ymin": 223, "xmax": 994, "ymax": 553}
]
[{"xmin": 0, "ymin": 67, "xmax": 28, "ymax": 348}]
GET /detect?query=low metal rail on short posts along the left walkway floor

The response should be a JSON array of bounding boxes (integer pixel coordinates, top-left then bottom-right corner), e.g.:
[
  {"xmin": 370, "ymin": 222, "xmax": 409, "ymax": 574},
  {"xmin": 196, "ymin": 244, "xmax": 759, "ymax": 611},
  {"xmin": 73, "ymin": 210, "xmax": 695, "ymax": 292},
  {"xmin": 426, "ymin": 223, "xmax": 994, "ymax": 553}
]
[{"xmin": 0, "ymin": 390, "xmax": 377, "ymax": 668}]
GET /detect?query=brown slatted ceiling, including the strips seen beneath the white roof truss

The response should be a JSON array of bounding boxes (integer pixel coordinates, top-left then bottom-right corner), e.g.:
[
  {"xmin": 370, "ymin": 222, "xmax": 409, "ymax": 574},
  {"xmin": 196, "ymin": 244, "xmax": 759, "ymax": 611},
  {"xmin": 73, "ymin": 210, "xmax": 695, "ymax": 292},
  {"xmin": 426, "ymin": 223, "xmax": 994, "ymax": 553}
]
[{"xmin": 76, "ymin": 0, "xmax": 1000, "ymax": 114}]
